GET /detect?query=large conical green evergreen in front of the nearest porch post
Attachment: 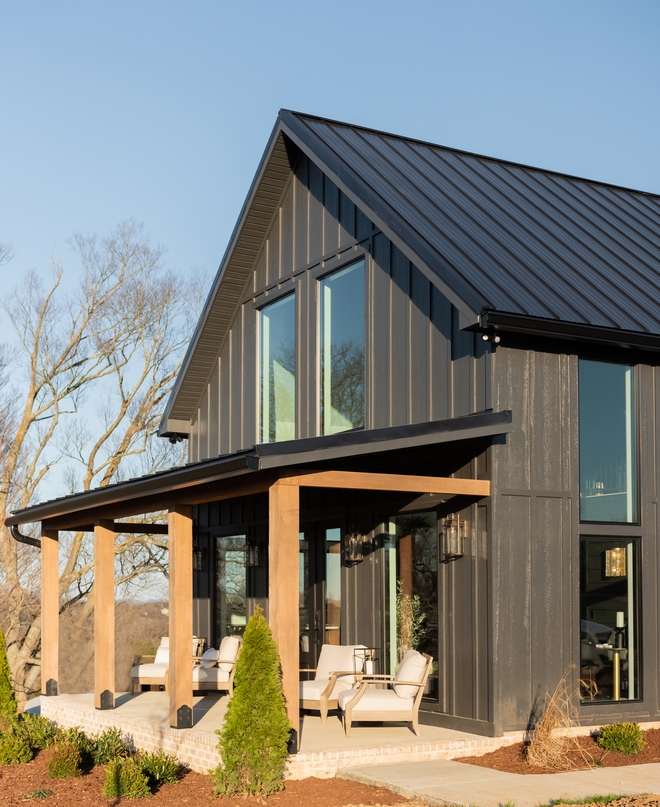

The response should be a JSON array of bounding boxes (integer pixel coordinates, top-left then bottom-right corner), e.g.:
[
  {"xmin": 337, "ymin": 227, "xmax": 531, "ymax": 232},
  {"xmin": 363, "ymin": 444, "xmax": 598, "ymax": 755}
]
[{"xmin": 213, "ymin": 606, "xmax": 291, "ymax": 796}]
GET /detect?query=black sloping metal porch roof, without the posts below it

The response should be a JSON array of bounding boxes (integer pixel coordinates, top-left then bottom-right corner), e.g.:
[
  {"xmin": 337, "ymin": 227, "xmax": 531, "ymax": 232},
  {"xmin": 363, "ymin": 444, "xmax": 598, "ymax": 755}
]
[{"xmin": 6, "ymin": 411, "xmax": 512, "ymax": 531}]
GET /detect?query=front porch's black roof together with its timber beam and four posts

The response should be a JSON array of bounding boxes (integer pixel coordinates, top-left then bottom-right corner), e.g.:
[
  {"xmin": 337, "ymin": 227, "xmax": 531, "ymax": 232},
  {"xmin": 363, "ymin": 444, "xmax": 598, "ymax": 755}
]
[{"xmin": 8, "ymin": 412, "xmax": 511, "ymax": 753}]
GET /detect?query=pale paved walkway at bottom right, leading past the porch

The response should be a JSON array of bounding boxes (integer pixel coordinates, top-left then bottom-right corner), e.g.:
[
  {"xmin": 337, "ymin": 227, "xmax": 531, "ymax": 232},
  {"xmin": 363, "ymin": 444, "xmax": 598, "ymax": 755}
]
[{"xmin": 337, "ymin": 759, "xmax": 660, "ymax": 807}]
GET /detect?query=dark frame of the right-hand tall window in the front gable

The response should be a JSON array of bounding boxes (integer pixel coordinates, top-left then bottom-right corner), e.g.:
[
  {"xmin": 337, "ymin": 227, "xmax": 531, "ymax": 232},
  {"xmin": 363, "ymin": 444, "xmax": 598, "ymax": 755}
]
[{"xmin": 310, "ymin": 256, "xmax": 370, "ymax": 437}]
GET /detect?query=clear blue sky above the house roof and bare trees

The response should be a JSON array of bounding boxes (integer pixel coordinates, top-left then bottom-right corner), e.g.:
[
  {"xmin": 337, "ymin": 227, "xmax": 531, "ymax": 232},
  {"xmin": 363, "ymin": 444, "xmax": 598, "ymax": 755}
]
[{"xmin": 0, "ymin": 0, "xmax": 660, "ymax": 284}]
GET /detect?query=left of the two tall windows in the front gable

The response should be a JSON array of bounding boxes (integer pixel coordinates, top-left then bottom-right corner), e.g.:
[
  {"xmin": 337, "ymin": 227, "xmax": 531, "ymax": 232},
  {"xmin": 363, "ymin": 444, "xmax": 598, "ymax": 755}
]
[{"xmin": 259, "ymin": 294, "xmax": 296, "ymax": 443}]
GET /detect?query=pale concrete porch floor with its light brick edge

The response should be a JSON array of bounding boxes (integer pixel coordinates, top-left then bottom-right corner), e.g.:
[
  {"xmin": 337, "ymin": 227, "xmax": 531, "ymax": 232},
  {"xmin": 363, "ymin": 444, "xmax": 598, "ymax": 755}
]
[{"xmin": 41, "ymin": 692, "xmax": 520, "ymax": 779}]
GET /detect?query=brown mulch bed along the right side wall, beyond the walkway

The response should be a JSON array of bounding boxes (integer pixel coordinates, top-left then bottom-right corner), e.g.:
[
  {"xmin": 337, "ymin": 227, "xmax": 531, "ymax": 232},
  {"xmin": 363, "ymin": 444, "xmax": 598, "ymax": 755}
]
[{"xmin": 456, "ymin": 729, "xmax": 660, "ymax": 772}]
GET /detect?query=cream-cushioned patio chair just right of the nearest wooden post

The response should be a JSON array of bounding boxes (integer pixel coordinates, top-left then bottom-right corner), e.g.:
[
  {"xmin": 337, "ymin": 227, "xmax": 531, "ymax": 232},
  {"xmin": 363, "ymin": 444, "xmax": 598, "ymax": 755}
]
[{"xmin": 300, "ymin": 644, "xmax": 365, "ymax": 725}]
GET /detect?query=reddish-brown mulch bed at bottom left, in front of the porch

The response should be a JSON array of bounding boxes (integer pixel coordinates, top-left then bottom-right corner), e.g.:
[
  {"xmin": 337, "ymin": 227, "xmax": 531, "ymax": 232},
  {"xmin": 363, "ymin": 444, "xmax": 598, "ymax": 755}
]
[{"xmin": 0, "ymin": 751, "xmax": 408, "ymax": 807}]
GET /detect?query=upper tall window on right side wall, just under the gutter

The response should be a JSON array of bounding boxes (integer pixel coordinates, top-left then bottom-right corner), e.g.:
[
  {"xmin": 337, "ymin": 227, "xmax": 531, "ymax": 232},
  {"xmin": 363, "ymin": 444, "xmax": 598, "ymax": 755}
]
[{"xmin": 579, "ymin": 359, "xmax": 637, "ymax": 523}]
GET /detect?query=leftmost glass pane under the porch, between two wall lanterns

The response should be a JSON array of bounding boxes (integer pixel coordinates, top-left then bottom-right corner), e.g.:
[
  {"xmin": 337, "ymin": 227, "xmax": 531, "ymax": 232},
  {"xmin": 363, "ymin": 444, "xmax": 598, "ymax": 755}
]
[{"xmin": 215, "ymin": 535, "xmax": 247, "ymax": 643}]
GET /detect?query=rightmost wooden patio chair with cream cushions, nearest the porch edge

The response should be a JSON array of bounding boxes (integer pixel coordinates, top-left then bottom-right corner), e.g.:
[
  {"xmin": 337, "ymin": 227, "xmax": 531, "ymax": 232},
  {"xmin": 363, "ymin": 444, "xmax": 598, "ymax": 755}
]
[{"xmin": 338, "ymin": 650, "xmax": 433, "ymax": 737}]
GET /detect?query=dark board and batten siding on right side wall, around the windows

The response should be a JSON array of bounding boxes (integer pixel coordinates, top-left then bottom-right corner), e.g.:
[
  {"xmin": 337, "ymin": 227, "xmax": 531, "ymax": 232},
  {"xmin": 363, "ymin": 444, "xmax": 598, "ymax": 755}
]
[{"xmin": 489, "ymin": 347, "xmax": 660, "ymax": 731}]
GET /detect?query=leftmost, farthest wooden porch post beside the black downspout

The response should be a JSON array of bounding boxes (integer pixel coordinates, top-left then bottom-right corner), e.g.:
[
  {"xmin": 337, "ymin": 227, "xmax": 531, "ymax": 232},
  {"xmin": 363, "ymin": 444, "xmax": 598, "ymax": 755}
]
[{"xmin": 41, "ymin": 527, "xmax": 60, "ymax": 695}]
